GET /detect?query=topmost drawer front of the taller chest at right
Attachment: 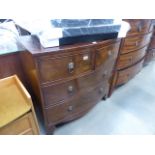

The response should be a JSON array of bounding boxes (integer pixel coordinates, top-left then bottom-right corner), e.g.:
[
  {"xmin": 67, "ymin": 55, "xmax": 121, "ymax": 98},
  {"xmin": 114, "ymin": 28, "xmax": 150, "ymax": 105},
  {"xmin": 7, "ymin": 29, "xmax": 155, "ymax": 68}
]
[{"xmin": 125, "ymin": 19, "xmax": 151, "ymax": 36}]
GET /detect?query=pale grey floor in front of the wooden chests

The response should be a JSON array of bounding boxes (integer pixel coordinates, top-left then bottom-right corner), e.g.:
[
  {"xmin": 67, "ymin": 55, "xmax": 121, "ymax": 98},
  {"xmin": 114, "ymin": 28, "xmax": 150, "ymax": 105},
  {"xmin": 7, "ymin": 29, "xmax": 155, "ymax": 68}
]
[{"xmin": 40, "ymin": 62, "xmax": 155, "ymax": 135}]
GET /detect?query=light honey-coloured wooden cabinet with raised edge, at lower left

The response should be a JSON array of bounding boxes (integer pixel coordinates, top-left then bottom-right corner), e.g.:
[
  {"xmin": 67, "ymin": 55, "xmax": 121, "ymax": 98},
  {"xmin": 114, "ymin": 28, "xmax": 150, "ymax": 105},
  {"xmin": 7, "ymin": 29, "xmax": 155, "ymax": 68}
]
[{"xmin": 0, "ymin": 75, "xmax": 39, "ymax": 135}]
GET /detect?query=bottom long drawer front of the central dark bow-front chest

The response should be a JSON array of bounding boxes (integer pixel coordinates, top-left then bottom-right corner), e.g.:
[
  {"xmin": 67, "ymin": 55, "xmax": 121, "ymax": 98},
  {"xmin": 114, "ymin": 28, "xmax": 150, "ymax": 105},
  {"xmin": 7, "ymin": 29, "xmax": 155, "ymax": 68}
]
[{"xmin": 45, "ymin": 82, "xmax": 108, "ymax": 124}]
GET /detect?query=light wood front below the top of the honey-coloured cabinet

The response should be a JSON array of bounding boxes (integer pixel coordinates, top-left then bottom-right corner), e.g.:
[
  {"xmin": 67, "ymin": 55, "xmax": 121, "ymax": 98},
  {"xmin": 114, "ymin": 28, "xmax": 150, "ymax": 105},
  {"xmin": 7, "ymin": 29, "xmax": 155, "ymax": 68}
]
[{"xmin": 0, "ymin": 112, "xmax": 38, "ymax": 135}]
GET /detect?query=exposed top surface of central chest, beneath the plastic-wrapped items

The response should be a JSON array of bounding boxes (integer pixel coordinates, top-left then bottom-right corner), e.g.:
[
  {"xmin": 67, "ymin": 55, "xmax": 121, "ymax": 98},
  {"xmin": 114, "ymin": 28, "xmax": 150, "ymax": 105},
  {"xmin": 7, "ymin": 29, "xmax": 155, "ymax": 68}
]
[{"xmin": 20, "ymin": 36, "xmax": 120, "ymax": 56}]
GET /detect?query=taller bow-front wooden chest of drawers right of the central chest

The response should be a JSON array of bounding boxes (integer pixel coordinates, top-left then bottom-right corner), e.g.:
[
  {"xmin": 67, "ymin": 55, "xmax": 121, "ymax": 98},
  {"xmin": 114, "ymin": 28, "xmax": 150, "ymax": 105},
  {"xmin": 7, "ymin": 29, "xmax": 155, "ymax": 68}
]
[{"xmin": 109, "ymin": 19, "xmax": 153, "ymax": 95}]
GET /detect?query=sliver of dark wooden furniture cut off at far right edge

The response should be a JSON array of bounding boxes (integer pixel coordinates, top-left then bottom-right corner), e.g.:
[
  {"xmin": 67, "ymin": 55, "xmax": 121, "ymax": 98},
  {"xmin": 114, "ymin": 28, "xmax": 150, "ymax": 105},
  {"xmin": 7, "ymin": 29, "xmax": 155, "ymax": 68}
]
[{"xmin": 145, "ymin": 23, "xmax": 155, "ymax": 64}]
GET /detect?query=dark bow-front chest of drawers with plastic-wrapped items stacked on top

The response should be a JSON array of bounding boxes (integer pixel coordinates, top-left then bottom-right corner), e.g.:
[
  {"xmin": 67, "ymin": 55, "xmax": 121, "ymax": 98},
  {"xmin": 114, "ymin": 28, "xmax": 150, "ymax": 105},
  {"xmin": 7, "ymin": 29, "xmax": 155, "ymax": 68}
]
[{"xmin": 21, "ymin": 37, "xmax": 120, "ymax": 133}]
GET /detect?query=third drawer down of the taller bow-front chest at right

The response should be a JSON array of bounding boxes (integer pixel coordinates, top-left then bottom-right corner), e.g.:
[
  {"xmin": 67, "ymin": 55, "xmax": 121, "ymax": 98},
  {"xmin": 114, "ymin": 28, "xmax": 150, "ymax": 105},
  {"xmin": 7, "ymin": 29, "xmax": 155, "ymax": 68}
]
[{"xmin": 117, "ymin": 46, "xmax": 147, "ymax": 69}]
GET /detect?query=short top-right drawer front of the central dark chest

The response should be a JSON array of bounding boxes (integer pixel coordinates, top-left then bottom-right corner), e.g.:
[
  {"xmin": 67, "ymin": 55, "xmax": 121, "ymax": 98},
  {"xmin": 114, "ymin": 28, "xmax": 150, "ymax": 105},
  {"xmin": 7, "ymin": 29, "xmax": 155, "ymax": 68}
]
[{"xmin": 95, "ymin": 42, "xmax": 120, "ymax": 67}]
